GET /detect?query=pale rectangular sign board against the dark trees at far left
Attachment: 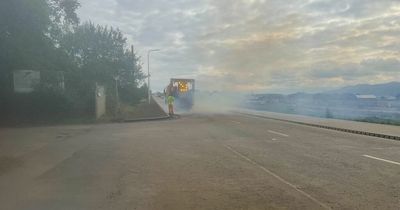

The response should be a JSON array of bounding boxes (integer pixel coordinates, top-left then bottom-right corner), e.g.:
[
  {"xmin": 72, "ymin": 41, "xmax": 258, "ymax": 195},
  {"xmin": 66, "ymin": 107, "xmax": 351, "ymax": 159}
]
[{"xmin": 14, "ymin": 70, "xmax": 40, "ymax": 93}]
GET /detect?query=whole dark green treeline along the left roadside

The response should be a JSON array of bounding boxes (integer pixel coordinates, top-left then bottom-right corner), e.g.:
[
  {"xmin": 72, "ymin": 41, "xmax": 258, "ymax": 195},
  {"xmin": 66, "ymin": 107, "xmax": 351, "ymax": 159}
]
[{"xmin": 0, "ymin": 0, "xmax": 146, "ymax": 124}]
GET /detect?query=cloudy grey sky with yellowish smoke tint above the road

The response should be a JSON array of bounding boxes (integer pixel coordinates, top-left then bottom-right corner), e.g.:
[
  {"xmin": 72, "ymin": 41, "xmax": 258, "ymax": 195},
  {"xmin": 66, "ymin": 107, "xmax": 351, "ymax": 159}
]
[{"xmin": 78, "ymin": 0, "xmax": 400, "ymax": 93}]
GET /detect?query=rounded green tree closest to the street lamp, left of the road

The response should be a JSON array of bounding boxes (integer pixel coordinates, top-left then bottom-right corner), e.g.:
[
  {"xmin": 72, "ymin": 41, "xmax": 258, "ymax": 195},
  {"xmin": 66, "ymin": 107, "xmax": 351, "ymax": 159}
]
[{"xmin": 61, "ymin": 22, "xmax": 144, "ymax": 113}]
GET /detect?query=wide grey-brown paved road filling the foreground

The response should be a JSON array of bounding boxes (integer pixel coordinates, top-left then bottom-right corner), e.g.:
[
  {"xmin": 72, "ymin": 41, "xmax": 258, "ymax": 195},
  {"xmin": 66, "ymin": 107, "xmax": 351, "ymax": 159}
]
[{"xmin": 0, "ymin": 114, "xmax": 400, "ymax": 210}]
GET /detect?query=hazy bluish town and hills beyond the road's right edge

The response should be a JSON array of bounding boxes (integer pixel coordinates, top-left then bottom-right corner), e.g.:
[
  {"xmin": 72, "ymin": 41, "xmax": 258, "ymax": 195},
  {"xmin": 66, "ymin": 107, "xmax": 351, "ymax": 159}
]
[{"xmin": 245, "ymin": 83, "xmax": 400, "ymax": 125}]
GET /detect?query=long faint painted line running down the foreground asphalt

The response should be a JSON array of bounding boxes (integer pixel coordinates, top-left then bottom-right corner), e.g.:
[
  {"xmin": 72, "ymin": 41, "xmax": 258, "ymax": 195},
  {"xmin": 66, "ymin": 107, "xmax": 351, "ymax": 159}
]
[{"xmin": 225, "ymin": 146, "xmax": 331, "ymax": 209}]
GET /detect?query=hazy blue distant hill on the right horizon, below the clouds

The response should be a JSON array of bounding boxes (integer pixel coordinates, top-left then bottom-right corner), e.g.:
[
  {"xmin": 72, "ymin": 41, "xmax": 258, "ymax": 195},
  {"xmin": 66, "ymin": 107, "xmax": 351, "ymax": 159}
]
[{"xmin": 326, "ymin": 82, "xmax": 400, "ymax": 96}]
